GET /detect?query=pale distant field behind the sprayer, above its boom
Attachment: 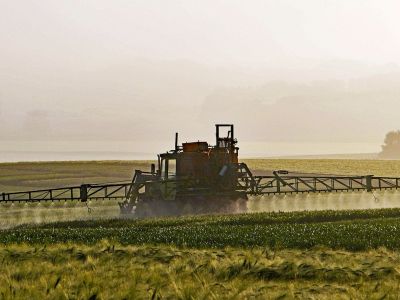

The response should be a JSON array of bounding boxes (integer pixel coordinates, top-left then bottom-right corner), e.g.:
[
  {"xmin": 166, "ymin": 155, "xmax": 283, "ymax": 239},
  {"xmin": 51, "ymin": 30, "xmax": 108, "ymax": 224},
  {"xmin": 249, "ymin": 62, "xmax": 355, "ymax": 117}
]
[{"xmin": 0, "ymin": 159, "xmax": 400, "ymax": 192}]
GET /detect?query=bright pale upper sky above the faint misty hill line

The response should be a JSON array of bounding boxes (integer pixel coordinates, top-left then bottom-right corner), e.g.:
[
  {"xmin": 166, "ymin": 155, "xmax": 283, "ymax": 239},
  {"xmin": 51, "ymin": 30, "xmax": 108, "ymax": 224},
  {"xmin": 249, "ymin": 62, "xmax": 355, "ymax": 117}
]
[{"xmin": 0, "ymin": 0, "xmax": 400, "ymax": 68}]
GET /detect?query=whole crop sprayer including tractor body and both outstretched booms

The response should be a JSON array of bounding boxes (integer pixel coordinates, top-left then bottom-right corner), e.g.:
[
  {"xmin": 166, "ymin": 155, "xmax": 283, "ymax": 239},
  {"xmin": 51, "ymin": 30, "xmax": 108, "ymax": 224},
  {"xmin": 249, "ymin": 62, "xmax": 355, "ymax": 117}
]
[{"xmin": 0, "ymin": 124, "xmax": 400, "ymax": 217}]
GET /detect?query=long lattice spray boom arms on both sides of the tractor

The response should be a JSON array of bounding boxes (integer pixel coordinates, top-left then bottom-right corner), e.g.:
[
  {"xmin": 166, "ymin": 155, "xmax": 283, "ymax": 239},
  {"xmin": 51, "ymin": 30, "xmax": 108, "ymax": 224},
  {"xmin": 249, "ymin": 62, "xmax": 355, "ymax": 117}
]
[{"xmin": 0, "ymin": 168, "xmax": 400, "ymax": 206}]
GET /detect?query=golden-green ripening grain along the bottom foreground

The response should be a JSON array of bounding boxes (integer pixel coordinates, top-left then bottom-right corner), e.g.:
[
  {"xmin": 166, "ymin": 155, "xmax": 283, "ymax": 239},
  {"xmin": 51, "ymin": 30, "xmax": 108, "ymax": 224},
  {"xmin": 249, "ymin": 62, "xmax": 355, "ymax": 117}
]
[{"xmin": 0, "ymin": 241, "xmax": 400, "ymax": 299}]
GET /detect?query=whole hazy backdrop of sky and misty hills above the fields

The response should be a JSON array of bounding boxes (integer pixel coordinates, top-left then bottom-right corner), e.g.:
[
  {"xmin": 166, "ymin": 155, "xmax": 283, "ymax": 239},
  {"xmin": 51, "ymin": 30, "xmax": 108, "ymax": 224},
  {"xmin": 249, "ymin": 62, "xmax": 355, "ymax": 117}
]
[{"xmin": 0, "ymin": 0, "xmax": 400, "ymax": 158}]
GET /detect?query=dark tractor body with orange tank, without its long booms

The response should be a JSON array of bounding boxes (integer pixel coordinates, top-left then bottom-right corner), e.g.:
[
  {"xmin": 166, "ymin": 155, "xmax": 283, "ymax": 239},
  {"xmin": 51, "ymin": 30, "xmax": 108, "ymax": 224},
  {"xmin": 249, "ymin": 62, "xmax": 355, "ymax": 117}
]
[{"xmin": 119, "ymin": 124, "xmax": 251, "ymax": 218}]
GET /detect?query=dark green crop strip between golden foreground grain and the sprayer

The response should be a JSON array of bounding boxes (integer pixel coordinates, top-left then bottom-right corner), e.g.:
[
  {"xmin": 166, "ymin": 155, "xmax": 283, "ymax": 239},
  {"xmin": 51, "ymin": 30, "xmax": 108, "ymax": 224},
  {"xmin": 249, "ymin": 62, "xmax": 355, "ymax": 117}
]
[{"xmin": 0, "ymin": 209, "xmax": 400, "ymax": 251}]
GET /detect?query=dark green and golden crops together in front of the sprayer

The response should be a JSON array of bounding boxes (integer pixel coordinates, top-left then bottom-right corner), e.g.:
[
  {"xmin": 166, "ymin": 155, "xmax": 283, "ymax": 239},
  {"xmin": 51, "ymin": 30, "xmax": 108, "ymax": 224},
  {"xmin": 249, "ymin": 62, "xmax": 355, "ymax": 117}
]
[{"xmin": 0, "ymin": 209, "xmax": 400, "ymax": 299}]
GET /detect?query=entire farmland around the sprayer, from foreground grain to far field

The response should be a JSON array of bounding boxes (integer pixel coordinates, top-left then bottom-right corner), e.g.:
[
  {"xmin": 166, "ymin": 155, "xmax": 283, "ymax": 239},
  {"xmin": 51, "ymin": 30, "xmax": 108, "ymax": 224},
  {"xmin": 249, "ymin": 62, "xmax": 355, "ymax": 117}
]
[{"xmin": 0, "ymin": 160, "xmax": 400, "ymax": 299}]
